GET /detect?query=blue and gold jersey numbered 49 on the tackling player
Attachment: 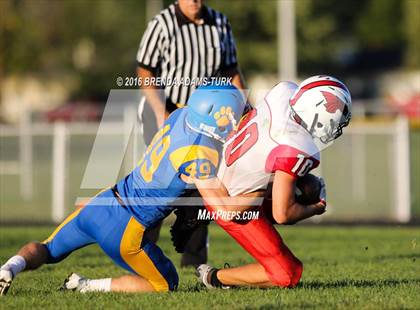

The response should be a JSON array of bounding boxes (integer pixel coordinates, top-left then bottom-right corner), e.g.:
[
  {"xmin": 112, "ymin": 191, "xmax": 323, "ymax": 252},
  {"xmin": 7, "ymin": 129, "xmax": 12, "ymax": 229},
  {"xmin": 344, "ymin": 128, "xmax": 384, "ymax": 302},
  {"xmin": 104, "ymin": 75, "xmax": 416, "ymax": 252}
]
[{"xmin": 117, "ymin": 107, "xmax": 222, "ymax": 227}]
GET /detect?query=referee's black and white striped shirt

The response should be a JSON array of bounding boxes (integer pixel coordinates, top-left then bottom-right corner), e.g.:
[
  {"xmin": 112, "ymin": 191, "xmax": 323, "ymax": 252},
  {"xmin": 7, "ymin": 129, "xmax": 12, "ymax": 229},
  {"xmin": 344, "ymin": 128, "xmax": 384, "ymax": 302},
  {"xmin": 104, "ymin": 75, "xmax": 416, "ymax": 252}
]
[{"xmin": 137, "ymin": 3, "xmax": 237, "ymax": 104}]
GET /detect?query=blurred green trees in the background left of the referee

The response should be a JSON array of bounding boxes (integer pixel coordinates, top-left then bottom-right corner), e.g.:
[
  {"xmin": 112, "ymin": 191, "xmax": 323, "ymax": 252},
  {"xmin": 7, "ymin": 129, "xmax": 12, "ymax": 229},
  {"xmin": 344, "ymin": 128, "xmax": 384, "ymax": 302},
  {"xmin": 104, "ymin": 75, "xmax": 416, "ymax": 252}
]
[{"xmin": 0, "ymin": 0, "xmax": 145, "ymax": 99}]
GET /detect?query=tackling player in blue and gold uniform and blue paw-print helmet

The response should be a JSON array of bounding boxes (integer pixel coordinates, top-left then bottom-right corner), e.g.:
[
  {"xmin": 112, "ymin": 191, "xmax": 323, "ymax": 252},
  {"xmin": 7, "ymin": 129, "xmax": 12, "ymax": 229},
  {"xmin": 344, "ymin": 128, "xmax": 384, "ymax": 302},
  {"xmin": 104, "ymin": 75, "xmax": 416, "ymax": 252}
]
[{"xmin": 0, "ymin": 85, "xmax": 245, "ymax": 295}]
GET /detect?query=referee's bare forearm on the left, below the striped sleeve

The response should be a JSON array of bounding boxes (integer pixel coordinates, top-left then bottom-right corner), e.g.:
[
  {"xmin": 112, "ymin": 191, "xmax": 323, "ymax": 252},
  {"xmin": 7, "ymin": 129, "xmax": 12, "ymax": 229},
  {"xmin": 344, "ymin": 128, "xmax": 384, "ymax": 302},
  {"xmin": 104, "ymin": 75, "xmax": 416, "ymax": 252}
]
[{"xmin": 137, "ymin": 67, "xmax": 168, "ymax": 123}]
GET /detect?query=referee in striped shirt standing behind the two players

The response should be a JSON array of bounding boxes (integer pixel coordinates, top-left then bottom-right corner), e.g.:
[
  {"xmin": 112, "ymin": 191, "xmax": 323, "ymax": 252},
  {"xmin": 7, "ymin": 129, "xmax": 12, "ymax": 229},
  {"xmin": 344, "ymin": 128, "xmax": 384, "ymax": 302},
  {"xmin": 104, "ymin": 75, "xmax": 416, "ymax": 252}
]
[{"xmin": 137, "ymin": 0, "xmax": 245, "ymax": 266}]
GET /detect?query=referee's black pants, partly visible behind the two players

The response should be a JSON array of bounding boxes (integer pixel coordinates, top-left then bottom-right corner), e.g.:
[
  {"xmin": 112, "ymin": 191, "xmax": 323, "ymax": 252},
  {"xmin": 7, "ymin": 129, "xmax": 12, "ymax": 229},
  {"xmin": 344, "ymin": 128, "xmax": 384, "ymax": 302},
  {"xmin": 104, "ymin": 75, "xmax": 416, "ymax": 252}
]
[{"xmin": 142, "ymin": 101, "xmax": 208, "ymax": 267}]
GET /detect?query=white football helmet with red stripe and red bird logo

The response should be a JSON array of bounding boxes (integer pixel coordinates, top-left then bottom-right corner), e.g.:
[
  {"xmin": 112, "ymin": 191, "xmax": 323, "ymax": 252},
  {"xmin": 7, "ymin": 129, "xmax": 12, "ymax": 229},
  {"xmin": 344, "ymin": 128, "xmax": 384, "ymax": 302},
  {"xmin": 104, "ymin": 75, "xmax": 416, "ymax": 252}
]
[{"xmin": 289, "ymin": 75, "xmax": 351, "ymax": 144}]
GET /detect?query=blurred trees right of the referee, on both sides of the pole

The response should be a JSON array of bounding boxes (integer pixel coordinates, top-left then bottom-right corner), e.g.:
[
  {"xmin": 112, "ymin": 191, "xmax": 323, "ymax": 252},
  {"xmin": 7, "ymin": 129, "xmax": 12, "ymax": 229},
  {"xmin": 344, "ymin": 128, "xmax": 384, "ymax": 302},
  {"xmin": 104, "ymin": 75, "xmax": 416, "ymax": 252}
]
[{"xmin": 212, "ymin": 0, "xmax": 420, "ymax": 75}]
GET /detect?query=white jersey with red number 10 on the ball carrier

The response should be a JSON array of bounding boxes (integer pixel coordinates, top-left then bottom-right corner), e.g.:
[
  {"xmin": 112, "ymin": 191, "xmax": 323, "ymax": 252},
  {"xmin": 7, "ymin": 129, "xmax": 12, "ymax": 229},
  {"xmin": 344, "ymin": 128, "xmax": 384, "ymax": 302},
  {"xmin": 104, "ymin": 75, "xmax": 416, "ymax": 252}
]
[{"xmin": 218, "ymin": 82, "xmax": 320, "ymax": 196}]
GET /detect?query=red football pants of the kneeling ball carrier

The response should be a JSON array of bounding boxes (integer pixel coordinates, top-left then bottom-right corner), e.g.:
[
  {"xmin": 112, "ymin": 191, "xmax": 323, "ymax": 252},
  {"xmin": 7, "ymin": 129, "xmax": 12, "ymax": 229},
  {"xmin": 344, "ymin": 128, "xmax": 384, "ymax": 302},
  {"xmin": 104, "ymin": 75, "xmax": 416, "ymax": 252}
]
[{"xmin": 206, "ymin": 206, "xmax": 303, "ymax": 287}]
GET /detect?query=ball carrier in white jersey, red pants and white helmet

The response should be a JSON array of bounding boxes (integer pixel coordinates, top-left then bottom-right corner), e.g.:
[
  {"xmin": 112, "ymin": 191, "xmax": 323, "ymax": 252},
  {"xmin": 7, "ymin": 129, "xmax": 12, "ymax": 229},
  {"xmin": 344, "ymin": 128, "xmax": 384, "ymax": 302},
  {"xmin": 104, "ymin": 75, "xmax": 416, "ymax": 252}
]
[{"xmin": 197, "ymin": 76, "xmax": 351, "ymax": 288}]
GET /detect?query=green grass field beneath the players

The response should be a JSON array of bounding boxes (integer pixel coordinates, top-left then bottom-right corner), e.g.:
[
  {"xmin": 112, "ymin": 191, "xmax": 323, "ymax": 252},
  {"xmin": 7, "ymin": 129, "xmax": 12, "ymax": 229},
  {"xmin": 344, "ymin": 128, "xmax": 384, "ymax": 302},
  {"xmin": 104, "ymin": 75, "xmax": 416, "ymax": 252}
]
[{"xmin": 0, "ymin": 224, "xmax": 420, "ymax": 309}]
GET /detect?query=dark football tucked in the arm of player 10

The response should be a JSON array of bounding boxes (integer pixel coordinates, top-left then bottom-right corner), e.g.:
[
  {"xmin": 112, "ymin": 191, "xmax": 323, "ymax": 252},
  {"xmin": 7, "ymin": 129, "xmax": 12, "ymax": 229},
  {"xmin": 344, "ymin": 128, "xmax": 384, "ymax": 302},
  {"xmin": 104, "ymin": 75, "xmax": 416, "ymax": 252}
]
[{"xmin": 295, "ymin": 173, "xmax": 321, "ymax": 206}]
